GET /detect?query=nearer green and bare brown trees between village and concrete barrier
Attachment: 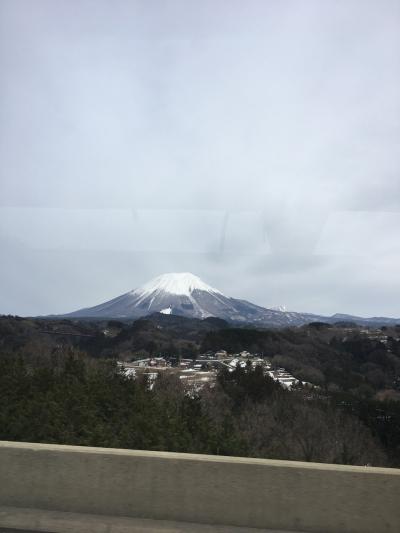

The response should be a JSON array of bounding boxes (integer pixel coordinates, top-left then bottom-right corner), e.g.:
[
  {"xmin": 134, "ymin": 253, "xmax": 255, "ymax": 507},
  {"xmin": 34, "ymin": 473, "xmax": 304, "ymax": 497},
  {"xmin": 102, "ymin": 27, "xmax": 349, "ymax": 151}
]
[{"xmin": 0, "ymin": 347, "xmax": 398, "ymax": 466}]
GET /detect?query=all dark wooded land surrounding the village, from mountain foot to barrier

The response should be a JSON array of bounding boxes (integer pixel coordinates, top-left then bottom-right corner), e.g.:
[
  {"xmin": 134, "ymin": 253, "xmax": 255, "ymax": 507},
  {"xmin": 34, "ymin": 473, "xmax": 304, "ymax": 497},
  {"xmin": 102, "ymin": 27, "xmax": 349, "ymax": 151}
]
[{"xmin": 0, "ymin": 315, "xmax": 400, "ymax": 466}]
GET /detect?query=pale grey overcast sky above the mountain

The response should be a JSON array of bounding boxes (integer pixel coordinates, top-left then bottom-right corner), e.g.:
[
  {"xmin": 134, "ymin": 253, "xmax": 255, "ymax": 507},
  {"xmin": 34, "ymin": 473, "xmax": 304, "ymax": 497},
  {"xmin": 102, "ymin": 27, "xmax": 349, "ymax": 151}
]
[{"xmin": 0, "ymin": 0, "xmax": 400, "ymax": 317}]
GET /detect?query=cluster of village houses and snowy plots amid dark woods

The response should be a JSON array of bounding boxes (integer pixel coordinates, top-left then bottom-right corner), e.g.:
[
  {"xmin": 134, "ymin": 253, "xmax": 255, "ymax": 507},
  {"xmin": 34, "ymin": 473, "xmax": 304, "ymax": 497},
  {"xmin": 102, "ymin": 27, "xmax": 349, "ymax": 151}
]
[{"xmin": 118, "ymin": 350, "xmax": 314, "ymax": 390}]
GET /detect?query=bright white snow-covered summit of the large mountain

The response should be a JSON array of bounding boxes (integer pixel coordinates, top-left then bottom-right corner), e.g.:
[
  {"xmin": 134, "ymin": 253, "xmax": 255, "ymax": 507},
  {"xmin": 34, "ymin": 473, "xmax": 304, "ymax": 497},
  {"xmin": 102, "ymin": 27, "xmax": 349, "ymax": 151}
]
[{"xmin": 132, "ymin": 272, "xmax": 222, "ymax": 297}]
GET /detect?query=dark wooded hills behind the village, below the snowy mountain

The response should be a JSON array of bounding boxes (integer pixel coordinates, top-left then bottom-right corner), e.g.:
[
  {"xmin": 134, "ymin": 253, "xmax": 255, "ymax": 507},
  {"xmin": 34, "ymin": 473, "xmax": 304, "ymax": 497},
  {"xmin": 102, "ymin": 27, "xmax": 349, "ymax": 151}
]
[{"xmin": 0, "ymin": 313, "xmax": 400, "ymax": 398}]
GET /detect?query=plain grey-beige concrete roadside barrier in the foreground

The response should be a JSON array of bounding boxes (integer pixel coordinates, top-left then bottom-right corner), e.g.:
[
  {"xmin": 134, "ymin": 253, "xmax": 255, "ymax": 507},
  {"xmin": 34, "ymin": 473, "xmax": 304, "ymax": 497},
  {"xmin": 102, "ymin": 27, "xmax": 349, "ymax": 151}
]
[{"xmin": 0, "ymin": 442, "xmax": 400, "ymax": 533}]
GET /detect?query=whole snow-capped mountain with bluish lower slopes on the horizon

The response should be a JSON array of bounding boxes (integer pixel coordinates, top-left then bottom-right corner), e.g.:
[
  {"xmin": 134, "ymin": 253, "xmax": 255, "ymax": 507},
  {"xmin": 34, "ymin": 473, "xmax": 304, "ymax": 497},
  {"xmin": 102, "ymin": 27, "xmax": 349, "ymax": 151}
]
[{"xmin": 63, "ymin": 272, "xmax": 396, "ymax": 327}]
